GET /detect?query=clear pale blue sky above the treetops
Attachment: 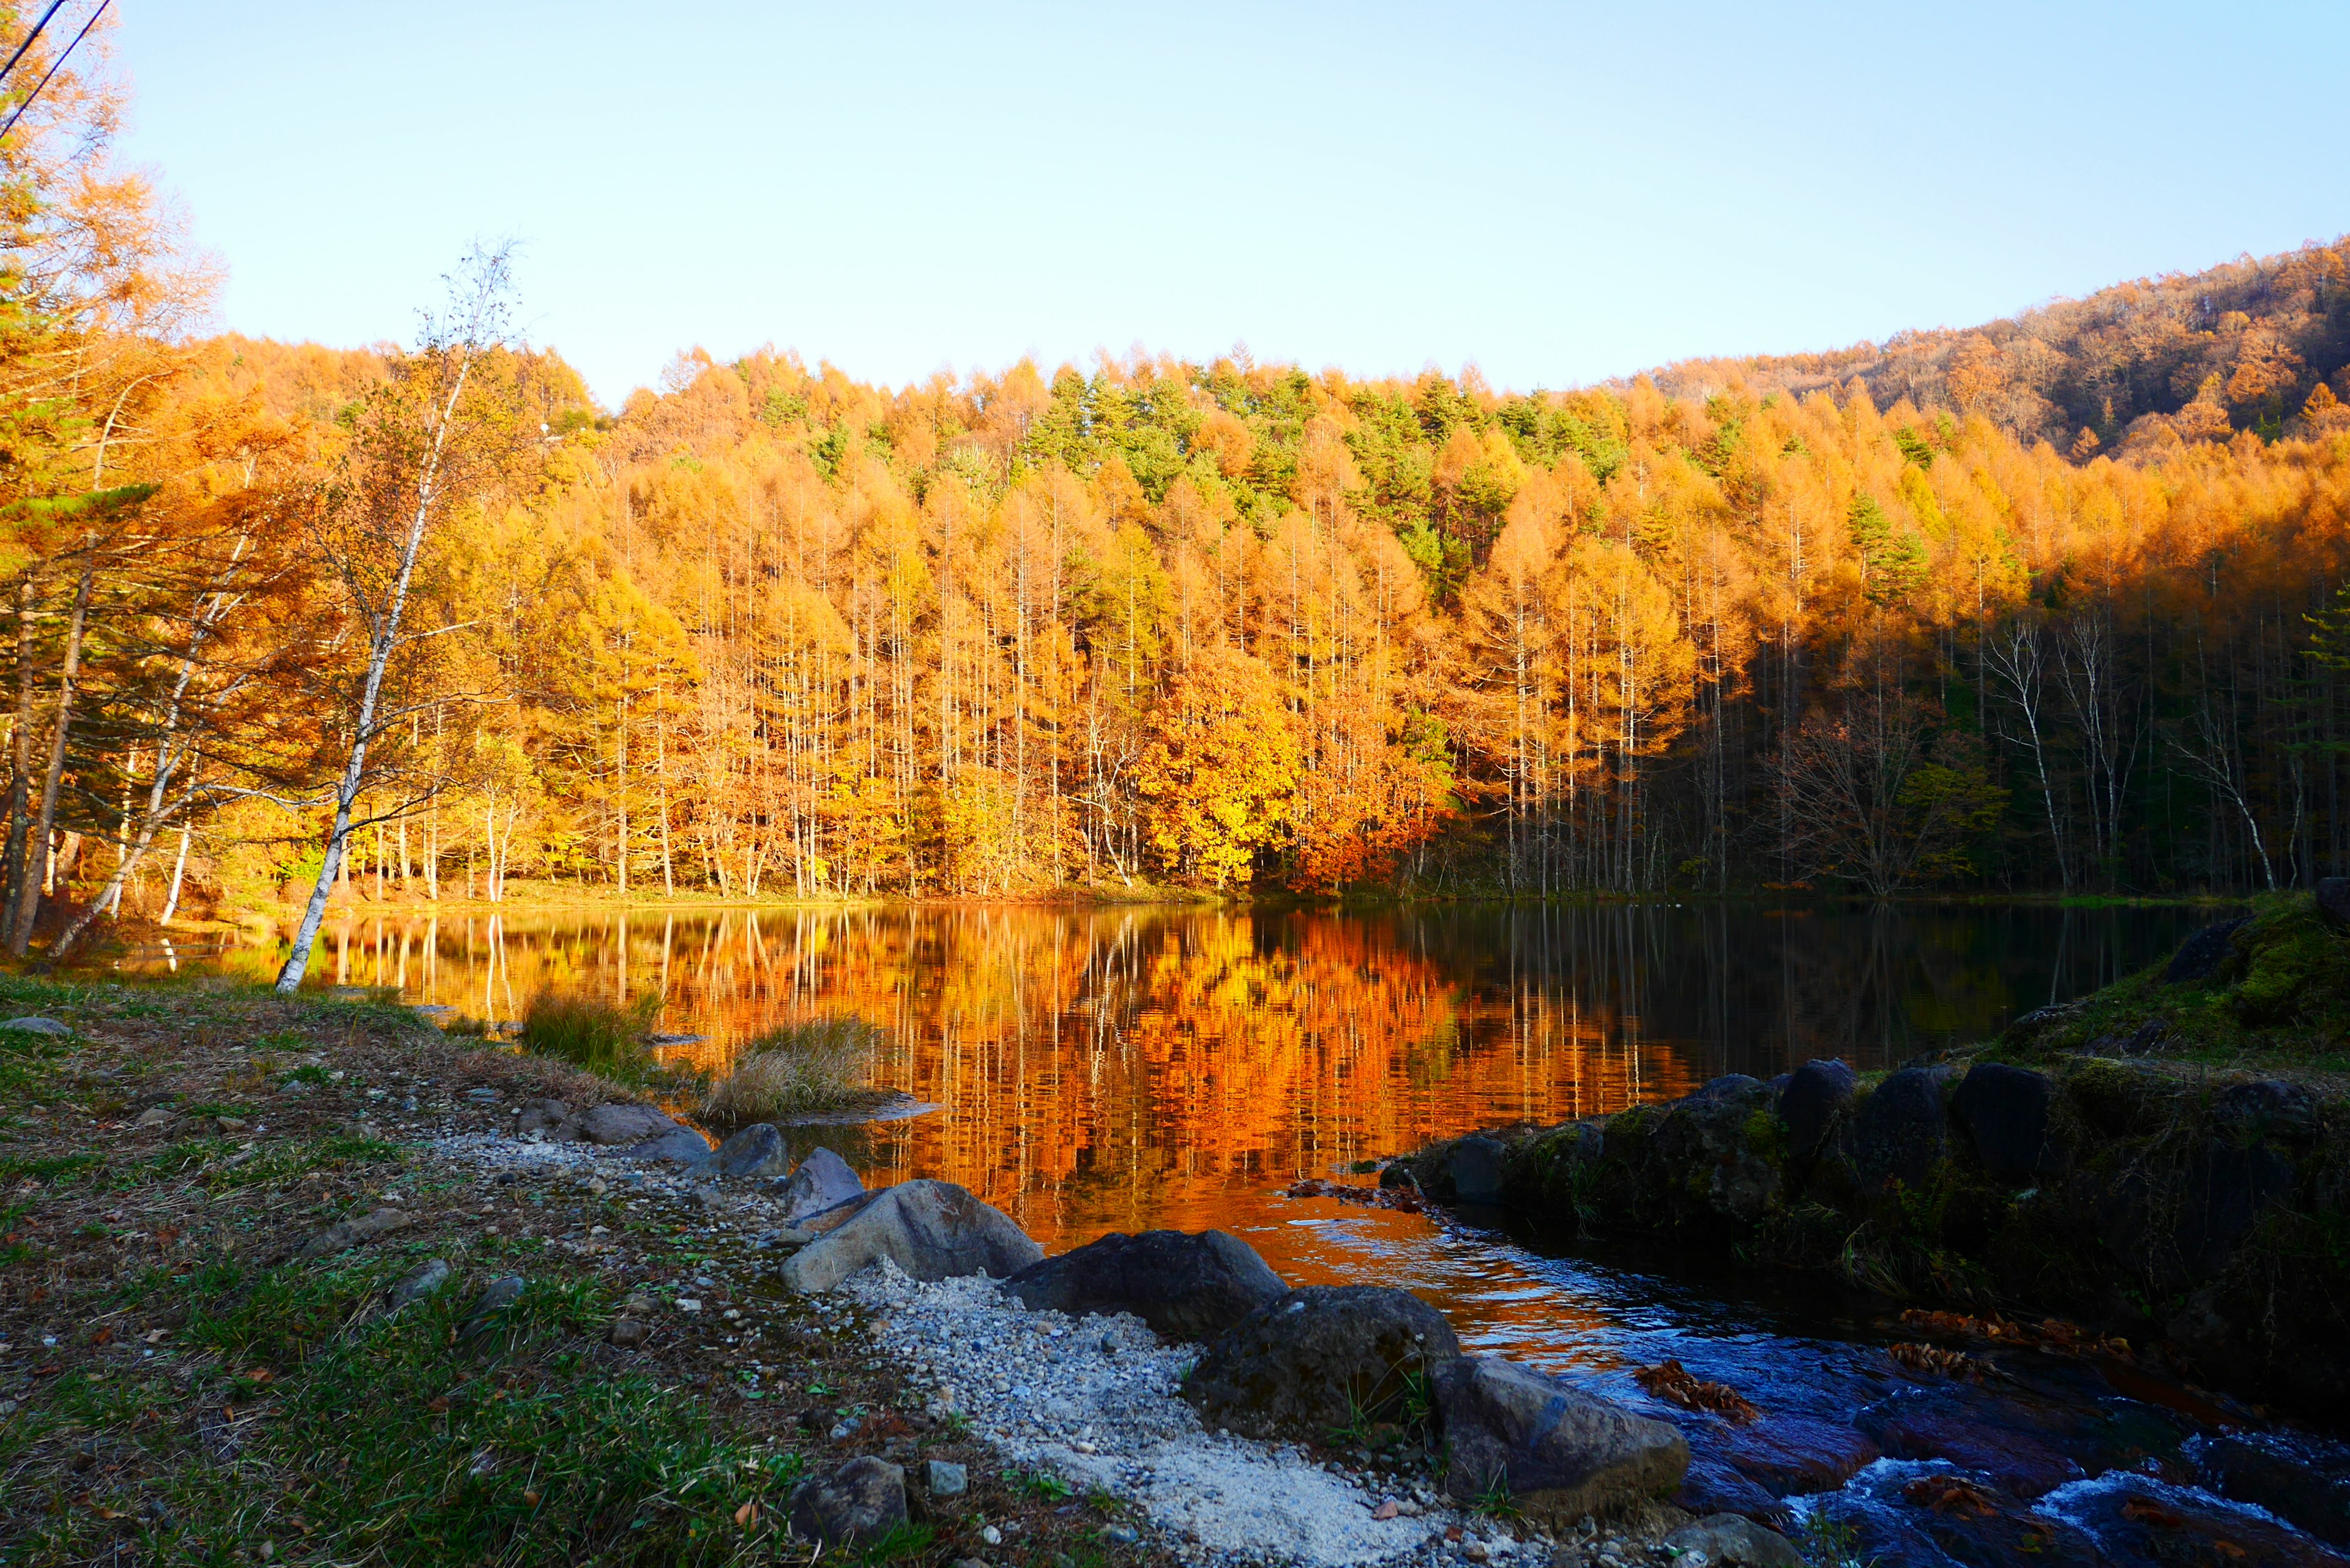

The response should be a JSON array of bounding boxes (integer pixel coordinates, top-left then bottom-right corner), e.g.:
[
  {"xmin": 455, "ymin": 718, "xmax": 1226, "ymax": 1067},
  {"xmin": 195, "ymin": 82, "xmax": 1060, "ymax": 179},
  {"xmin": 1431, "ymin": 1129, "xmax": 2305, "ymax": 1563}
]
[{"xmin": 110, "ymin": 0, "xmax": 2350, "ymax": 405}]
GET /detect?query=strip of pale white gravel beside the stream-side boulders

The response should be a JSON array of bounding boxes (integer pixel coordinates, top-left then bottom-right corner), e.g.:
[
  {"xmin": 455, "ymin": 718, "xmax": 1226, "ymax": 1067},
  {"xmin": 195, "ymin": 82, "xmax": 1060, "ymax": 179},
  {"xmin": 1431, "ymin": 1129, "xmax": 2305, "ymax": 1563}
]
[{"xmin": 846, "ymin": 1263, "xmax": 1544, "ymax": 1568}]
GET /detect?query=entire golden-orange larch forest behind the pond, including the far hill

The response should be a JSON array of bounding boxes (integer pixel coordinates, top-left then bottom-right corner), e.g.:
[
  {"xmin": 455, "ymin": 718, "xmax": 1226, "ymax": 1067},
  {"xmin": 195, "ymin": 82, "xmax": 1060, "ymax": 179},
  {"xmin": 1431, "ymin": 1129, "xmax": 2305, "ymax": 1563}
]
[{"xmin": 0, "ymin": 37, "xmax": 2350, "ymax": 954}]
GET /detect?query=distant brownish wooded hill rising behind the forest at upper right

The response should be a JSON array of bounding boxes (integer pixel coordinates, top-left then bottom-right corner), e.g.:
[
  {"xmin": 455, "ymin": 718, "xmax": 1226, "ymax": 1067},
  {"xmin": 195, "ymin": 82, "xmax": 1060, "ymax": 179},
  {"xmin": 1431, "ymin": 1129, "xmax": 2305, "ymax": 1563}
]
[{"xmin": 1652, "ymin": 237, "xmax": 2350, "ymax": 458}]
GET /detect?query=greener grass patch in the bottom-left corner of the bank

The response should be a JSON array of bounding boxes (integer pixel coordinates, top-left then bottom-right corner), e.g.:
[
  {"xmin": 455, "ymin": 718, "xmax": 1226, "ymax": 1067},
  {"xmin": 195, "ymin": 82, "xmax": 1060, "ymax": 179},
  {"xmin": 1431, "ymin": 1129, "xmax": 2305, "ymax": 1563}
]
[{"xmin": 0, "ymin": 1249, "xmax": 808, "ymax": 1568}]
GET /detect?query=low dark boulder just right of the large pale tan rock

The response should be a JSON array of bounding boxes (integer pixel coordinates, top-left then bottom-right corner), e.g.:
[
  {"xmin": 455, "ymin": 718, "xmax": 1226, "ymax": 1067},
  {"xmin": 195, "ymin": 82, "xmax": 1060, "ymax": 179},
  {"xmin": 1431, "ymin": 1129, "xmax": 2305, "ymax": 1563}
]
[{"xmin": 1004, "ymin": 1230, "xmax": 1288, "ymax": 1340}]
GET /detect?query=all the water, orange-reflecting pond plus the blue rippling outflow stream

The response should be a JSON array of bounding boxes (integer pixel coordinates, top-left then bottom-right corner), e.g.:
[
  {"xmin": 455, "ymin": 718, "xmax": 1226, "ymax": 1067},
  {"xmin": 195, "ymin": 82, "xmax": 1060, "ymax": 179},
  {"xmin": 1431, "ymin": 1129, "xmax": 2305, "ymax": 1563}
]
[{"xmin": 137, "ymin": 905, "xmax": 2350, "ymax": 1568}]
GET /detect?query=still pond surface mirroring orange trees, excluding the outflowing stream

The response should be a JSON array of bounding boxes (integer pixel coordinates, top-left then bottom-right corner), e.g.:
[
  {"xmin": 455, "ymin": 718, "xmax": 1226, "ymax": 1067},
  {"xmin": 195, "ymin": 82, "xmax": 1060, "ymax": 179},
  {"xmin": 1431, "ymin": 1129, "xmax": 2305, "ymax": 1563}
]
[{"xmin": 142, "ymin": 905, "xmax": 2207, "ymax": 1277}]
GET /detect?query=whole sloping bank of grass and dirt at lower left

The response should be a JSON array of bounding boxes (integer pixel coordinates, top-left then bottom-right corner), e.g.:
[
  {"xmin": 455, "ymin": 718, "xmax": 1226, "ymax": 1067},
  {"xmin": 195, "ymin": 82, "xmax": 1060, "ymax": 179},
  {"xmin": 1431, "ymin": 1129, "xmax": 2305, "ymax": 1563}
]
[{"xmin": 0, "ymin": 976, "xmax": 1152, "ymax": 1566}]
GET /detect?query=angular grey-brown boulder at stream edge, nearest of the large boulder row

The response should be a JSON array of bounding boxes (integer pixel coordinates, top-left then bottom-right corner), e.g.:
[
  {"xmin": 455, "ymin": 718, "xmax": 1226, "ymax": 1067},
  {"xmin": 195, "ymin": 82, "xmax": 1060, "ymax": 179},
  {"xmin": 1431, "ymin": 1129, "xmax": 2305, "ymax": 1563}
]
[{"xmin": 1431, "ymin": 1356, "xmax": 1690, "ymax": 1526}]
